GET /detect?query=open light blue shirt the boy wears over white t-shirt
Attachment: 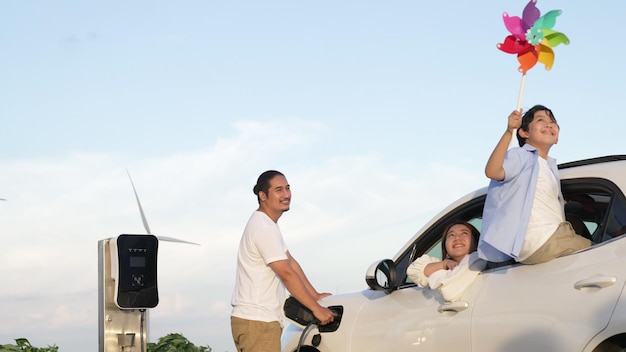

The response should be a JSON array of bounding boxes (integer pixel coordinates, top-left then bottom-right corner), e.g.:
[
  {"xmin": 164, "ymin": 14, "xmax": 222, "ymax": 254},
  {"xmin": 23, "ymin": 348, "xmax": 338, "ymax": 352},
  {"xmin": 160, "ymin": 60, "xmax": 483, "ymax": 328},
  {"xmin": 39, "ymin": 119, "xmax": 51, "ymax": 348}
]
[{"xmin": 478, "ymin": 144, "xmax": 563, "ymax": 262}]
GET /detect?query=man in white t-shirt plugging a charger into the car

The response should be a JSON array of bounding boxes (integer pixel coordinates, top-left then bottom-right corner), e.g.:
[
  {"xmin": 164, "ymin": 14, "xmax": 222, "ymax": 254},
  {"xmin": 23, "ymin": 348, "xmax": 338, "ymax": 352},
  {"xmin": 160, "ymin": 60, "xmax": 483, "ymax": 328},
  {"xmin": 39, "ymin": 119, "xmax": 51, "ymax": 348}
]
[{"xmin": 231, "ymin": 170, "xmax": 333, "ymax": 352}]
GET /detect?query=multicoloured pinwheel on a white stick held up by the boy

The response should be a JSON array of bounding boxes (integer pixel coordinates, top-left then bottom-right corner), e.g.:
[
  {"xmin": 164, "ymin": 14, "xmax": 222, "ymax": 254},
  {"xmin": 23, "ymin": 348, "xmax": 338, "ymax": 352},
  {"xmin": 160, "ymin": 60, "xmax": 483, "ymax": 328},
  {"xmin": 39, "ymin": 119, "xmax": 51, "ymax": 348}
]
[{"xmin": 497, "ymin": 0, "xmax": 569, "ymax": 109}]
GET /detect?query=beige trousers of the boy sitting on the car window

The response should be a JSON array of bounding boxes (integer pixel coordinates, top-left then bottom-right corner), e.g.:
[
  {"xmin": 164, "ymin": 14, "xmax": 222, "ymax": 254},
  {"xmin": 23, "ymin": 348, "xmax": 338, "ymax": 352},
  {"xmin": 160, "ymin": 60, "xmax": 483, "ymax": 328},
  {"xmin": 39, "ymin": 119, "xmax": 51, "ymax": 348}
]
[{"xmin": 520, "ymin": 221, "xmax": 591, "ymax": 264}]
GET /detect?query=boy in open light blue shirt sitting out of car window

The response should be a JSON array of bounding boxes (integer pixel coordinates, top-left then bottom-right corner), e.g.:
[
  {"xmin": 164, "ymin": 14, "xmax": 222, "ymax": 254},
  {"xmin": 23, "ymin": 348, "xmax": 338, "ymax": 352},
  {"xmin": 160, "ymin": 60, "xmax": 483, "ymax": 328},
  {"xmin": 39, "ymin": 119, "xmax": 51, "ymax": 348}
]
[{"xmin": 478, "ymin": 105, "xmax": 591, "ymax": 264}]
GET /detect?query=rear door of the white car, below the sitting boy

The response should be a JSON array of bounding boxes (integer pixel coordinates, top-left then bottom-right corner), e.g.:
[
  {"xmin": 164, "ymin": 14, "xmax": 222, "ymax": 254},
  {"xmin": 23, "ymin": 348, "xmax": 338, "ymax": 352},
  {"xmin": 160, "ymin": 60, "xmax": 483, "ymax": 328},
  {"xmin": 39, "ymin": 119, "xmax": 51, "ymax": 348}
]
[{"xmin": 471, "ymin": 239, "xmax": 626, "ymax": 352}]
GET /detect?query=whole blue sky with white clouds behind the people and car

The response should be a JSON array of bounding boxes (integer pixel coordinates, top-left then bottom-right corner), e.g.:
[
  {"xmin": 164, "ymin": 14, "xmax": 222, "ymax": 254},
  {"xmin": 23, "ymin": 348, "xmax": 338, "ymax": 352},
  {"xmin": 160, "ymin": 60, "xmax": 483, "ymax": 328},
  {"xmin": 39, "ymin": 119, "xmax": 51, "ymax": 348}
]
[{"xmin": 0, "ymin": 0, "xmax": 626, "ymax": 352}]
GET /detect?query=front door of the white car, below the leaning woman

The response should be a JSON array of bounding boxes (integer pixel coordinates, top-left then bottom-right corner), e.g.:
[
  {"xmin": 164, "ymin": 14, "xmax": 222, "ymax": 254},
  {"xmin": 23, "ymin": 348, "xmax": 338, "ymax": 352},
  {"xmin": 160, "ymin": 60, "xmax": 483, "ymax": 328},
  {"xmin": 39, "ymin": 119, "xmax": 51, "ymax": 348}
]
[{"xmin": 350, "ymin": 213, "xmax": 483, "ymax": 352}]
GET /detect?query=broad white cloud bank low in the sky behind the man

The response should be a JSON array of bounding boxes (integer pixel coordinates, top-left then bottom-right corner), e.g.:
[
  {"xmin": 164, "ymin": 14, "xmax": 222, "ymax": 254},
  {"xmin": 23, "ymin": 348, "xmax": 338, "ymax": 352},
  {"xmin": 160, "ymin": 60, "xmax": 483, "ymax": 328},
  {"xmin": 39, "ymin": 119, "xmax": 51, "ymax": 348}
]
[{"xmin": 0, "ymin": 121, "xmax": 483, "ymax": 350}]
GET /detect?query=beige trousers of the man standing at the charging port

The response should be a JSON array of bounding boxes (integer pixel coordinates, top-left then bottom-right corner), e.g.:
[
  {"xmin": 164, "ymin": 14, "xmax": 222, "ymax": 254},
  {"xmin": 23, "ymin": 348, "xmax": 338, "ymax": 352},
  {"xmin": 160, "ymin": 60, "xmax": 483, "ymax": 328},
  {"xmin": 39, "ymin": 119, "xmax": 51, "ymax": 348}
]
[{"xmin": 230, "ymin": 317, "xmax": 283, "ymax": 352}]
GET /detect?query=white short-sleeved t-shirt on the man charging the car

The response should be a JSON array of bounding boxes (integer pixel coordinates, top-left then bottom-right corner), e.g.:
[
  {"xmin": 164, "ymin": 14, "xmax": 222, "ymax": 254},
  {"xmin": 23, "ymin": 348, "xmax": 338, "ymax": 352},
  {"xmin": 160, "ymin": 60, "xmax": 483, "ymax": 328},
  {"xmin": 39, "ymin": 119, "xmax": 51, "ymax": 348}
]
[{"xmin": 231, "ymin": 210, "xmax": 287, "ymax": 322}]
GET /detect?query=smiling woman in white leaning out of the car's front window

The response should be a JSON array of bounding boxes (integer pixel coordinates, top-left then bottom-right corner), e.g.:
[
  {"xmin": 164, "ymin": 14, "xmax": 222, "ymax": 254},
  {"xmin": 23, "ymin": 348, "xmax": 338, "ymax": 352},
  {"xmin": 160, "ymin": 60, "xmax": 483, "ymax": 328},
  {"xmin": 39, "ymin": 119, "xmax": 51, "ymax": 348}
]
[{"xmin": 407, "ymin": 220, "xmax": 485, "ymax": 301}]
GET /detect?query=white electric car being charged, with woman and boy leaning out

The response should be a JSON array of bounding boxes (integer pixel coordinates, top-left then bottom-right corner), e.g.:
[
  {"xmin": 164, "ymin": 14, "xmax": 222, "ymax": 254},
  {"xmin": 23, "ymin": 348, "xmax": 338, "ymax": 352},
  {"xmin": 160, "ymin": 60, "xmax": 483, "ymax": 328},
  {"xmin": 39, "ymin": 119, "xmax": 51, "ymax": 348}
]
[{"xmin": 282, "ymin": 155, "xmax": 626, "ymax": 352}]
